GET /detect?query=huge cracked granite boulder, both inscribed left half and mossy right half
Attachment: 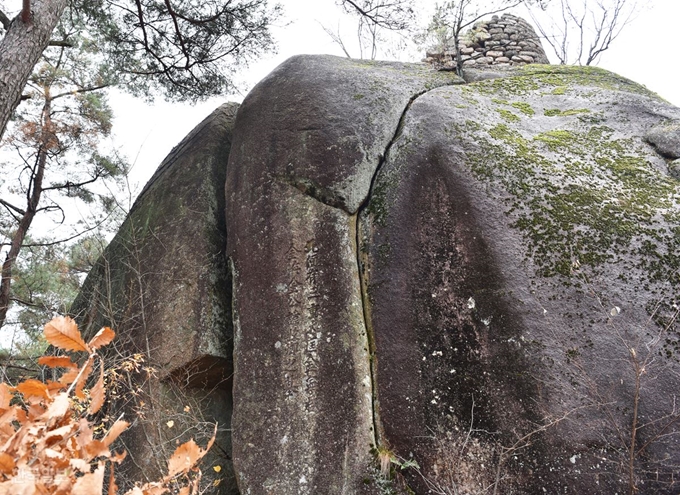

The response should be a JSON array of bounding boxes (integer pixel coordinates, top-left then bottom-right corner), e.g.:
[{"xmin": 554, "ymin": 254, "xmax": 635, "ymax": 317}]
[{"xmin": 226, "ymin": 57, "xmax": 680, "ymax": 495}]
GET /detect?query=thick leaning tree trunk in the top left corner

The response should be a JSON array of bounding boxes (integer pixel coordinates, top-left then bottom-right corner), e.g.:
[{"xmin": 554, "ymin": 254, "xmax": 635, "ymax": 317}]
[{"xmin": 0, "ymin": 0, "xmax": 68, "ymax": 137}]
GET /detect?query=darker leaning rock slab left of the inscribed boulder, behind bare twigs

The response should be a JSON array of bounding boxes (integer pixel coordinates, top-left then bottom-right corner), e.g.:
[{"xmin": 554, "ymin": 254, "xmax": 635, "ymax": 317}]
[{"xmin": 72, "ymin": 104, "xmax": 238, "ymax": 494}]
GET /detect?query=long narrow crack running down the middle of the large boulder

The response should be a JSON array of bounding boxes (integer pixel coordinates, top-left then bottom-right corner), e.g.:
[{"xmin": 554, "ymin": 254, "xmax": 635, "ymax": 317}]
[{"xmin": 353, "ymin": 90, "xmax": 431, "ymax": 448}]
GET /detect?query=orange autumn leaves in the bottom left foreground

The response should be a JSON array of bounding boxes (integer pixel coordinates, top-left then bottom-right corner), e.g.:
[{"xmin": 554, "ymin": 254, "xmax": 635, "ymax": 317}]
[{"xmin": 0, "ymin": 317, "xmax": 215, "ymax": 495}]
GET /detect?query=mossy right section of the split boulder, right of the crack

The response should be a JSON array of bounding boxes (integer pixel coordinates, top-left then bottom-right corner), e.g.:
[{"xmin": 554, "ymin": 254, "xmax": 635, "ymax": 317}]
[{"xmin": 360, "ymin": 60, "xmax": 680, "ymax": 494}]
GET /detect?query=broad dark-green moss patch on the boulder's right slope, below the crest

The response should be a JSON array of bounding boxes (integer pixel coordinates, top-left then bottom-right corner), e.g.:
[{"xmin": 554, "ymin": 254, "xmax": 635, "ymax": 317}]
[{"xmin": 458, "ymin": 113, "xmax": 680, "ymax": 281}]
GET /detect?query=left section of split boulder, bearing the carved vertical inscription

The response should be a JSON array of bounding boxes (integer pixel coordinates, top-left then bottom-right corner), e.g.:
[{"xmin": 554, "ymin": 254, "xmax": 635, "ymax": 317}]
[{"xmin": 226, "ymin": 57, "xmax": 462, "ymax": 494}]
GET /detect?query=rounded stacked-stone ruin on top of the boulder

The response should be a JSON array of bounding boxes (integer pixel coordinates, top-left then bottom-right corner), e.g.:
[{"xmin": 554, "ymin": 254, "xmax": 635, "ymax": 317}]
[{"xmin": 425, "ymin": 14, "xmax": 550, "ymax": 69}]
